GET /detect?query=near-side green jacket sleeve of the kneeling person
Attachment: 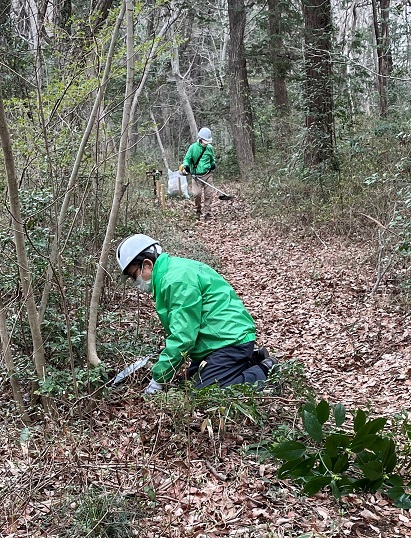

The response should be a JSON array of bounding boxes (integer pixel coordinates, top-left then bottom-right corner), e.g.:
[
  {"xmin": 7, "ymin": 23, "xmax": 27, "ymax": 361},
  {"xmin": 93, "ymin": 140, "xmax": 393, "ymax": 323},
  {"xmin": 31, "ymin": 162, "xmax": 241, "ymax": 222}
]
[{"xmin": 152, "ymin": 282, "xmax": 202, "ymax": 383}]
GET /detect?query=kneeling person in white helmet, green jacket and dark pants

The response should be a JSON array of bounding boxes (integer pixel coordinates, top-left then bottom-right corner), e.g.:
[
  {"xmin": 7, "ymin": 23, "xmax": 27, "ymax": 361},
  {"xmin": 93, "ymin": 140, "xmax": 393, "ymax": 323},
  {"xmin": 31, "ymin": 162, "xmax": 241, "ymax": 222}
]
[{"xmin": 117, "ymin": 234, "xmax": 277, "ymax": 394}]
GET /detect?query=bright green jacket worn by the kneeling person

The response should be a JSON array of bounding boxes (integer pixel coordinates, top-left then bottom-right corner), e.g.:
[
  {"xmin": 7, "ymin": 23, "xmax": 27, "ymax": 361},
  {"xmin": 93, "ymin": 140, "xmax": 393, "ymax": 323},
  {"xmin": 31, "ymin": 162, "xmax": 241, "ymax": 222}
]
[{"xmin": 151, "ymin": 253, "xmax": 255, "ymax": 383}]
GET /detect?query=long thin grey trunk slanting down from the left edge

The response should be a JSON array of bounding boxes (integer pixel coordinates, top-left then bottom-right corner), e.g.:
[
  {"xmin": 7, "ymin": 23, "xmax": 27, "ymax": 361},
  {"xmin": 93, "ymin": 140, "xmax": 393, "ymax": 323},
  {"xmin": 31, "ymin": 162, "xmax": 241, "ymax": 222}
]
[{"xmin": 0, "ymin": 87, "xmax": 52, "ymax": 412}]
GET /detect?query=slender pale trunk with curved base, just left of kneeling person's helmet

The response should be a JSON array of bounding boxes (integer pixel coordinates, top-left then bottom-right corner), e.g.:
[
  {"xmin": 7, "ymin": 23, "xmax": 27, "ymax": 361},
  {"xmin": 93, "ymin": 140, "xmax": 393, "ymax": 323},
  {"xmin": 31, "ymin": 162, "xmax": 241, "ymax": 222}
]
[{"xmin": 87, "ymin": 0, "xmax": 134, "ymax": 366}]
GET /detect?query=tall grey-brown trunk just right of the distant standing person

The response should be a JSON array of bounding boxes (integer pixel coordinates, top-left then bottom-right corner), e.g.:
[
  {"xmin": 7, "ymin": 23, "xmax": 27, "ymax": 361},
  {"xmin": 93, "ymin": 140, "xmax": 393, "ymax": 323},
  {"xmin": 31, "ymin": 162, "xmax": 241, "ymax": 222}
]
[{"xmin": 228, "ymin": 0, "xmax": 254, "ymax": 177}]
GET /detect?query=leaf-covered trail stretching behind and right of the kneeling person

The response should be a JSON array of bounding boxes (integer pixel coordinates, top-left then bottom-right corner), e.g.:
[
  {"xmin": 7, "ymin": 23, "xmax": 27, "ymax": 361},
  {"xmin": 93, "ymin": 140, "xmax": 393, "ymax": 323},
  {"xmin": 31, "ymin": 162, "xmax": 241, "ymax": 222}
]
[{"xmin": 197, "ymin": 200, "xmax": 411, "ymax": 415}]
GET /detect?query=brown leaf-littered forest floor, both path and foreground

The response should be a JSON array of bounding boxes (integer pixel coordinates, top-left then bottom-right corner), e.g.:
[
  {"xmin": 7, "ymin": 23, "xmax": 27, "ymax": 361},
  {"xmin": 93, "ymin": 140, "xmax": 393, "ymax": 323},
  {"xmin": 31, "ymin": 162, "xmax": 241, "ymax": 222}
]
[{"xmin": 0, "ymin": 186, "xmax": 411, "ymax": 538}]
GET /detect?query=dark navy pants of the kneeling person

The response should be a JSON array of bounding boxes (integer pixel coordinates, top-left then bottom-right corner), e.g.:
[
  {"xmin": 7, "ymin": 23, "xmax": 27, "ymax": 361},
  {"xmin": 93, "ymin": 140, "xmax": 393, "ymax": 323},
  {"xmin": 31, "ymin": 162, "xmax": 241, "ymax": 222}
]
[{"xmin": 188, "ymin": 342, "xmax": 267, "ymax": 389}]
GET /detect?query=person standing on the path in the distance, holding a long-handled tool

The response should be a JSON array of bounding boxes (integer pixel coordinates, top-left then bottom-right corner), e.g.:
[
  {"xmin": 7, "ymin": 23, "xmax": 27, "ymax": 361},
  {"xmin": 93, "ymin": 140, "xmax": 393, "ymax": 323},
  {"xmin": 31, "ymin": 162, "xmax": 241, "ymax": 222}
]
[{"xmin": 182, "ymin": 127, "xmax": 215, "ymax": 221}]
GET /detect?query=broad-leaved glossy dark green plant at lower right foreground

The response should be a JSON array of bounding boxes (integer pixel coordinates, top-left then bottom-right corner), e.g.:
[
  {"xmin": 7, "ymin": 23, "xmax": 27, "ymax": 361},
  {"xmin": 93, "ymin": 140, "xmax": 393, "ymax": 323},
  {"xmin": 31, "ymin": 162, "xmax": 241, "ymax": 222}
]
[{"xmin": 264, "ymin": 400, "xmax": 411, "ymax": 509}]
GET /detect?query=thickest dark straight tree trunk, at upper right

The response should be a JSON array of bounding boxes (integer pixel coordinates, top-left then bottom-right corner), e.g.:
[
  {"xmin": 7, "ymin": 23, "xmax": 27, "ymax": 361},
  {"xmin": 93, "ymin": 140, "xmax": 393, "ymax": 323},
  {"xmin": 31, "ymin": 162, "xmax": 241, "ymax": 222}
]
[{"xmin": 303, "ymin": 0, "xmax": 334, "ymax": 168}]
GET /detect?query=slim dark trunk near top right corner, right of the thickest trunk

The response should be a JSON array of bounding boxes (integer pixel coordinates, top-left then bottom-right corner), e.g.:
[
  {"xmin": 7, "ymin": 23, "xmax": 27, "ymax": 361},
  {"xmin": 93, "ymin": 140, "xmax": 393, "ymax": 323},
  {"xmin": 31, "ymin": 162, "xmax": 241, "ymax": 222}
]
[{"xmin": 372, "ymin": 0, "xmax": 392, "ymax": 118}]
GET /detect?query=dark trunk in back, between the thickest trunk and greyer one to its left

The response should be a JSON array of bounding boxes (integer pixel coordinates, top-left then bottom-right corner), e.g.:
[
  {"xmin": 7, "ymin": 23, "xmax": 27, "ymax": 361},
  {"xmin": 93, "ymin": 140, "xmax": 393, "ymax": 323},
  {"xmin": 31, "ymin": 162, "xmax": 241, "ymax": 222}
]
[{"xmin": 268, "ymin": 0, "xmax": 289, "ymax": 113}]
